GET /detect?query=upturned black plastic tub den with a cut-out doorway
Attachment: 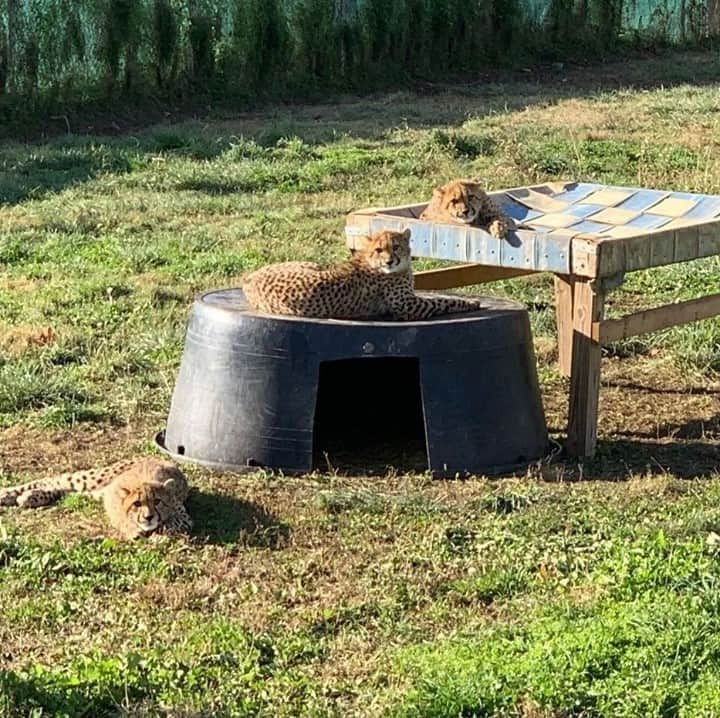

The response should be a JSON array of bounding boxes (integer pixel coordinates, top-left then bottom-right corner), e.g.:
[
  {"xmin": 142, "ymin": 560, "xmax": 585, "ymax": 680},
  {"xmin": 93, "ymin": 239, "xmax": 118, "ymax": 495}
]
[{"xmin": 153, "ymin": 289, "xmax": 547, "ymax": 477}]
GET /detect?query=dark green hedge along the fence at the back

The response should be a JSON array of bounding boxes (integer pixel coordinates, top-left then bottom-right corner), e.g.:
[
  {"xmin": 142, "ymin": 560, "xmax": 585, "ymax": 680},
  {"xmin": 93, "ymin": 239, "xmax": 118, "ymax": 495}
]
[{"xmin": 0, "ymin": 0, "xmax": 696, "ymax": 115}]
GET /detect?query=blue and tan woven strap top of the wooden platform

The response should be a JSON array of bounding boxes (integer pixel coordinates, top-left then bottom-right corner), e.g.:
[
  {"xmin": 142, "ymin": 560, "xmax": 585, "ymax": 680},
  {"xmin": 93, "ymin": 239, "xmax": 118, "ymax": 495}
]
[{"xmin": 345, "ymin": 182, "xmax": 720, "ymax": 277}]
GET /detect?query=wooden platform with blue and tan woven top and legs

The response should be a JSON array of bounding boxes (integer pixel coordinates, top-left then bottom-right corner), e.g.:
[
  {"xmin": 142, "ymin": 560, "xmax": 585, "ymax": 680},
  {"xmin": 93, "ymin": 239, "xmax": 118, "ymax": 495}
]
[{"xmin": 345, "ymin": 182, "xmax": 720, "ymax": 456}]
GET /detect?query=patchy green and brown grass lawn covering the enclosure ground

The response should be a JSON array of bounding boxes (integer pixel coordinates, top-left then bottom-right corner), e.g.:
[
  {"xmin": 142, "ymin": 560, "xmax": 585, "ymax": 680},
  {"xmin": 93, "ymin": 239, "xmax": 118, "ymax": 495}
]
[{"xmin": 0, "ymin": 53, "xmax": 720, "ymax": 718}]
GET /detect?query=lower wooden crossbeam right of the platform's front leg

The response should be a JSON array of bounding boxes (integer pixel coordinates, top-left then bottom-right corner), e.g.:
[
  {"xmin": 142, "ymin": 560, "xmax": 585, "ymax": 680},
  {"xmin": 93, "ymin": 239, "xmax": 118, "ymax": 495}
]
[{"xmin": 592, "ymin": 294, "xmax": 720, "ymax": 344}]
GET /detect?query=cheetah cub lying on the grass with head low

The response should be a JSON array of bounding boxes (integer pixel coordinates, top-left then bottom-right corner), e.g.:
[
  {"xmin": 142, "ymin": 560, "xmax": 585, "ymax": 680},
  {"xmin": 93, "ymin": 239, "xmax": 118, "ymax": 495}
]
[{"xmin": 0, "ymin": 458, "xmax": 192, "ymax": 539}]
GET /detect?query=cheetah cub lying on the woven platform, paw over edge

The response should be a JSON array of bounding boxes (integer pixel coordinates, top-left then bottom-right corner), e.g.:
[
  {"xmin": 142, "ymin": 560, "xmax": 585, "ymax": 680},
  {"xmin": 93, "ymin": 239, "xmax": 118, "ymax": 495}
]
[{"xmin": 420, "ymin": 180, "xmax": 512, "ymax": 239}]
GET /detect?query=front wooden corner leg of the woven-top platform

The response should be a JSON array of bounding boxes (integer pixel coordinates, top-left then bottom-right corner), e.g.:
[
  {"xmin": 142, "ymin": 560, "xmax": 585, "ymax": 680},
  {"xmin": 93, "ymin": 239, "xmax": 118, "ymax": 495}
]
[{"xmin": 566, "ymin": 277, "xmax": 605, "ymax": 456}]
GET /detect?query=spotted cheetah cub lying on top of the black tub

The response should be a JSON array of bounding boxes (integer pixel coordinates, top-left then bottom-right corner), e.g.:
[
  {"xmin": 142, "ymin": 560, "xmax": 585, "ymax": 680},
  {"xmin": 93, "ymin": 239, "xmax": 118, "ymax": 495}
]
[{"xmin": 243, "ymin": 229, "xmax": 480, "ymax": 320}]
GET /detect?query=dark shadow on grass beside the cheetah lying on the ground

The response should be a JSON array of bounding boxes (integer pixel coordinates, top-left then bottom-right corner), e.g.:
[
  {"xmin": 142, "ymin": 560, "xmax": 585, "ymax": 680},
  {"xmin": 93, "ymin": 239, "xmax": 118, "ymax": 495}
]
[{"xmin": 187, "ymin": 490, "xmax": 290, "ymax": 549}]
